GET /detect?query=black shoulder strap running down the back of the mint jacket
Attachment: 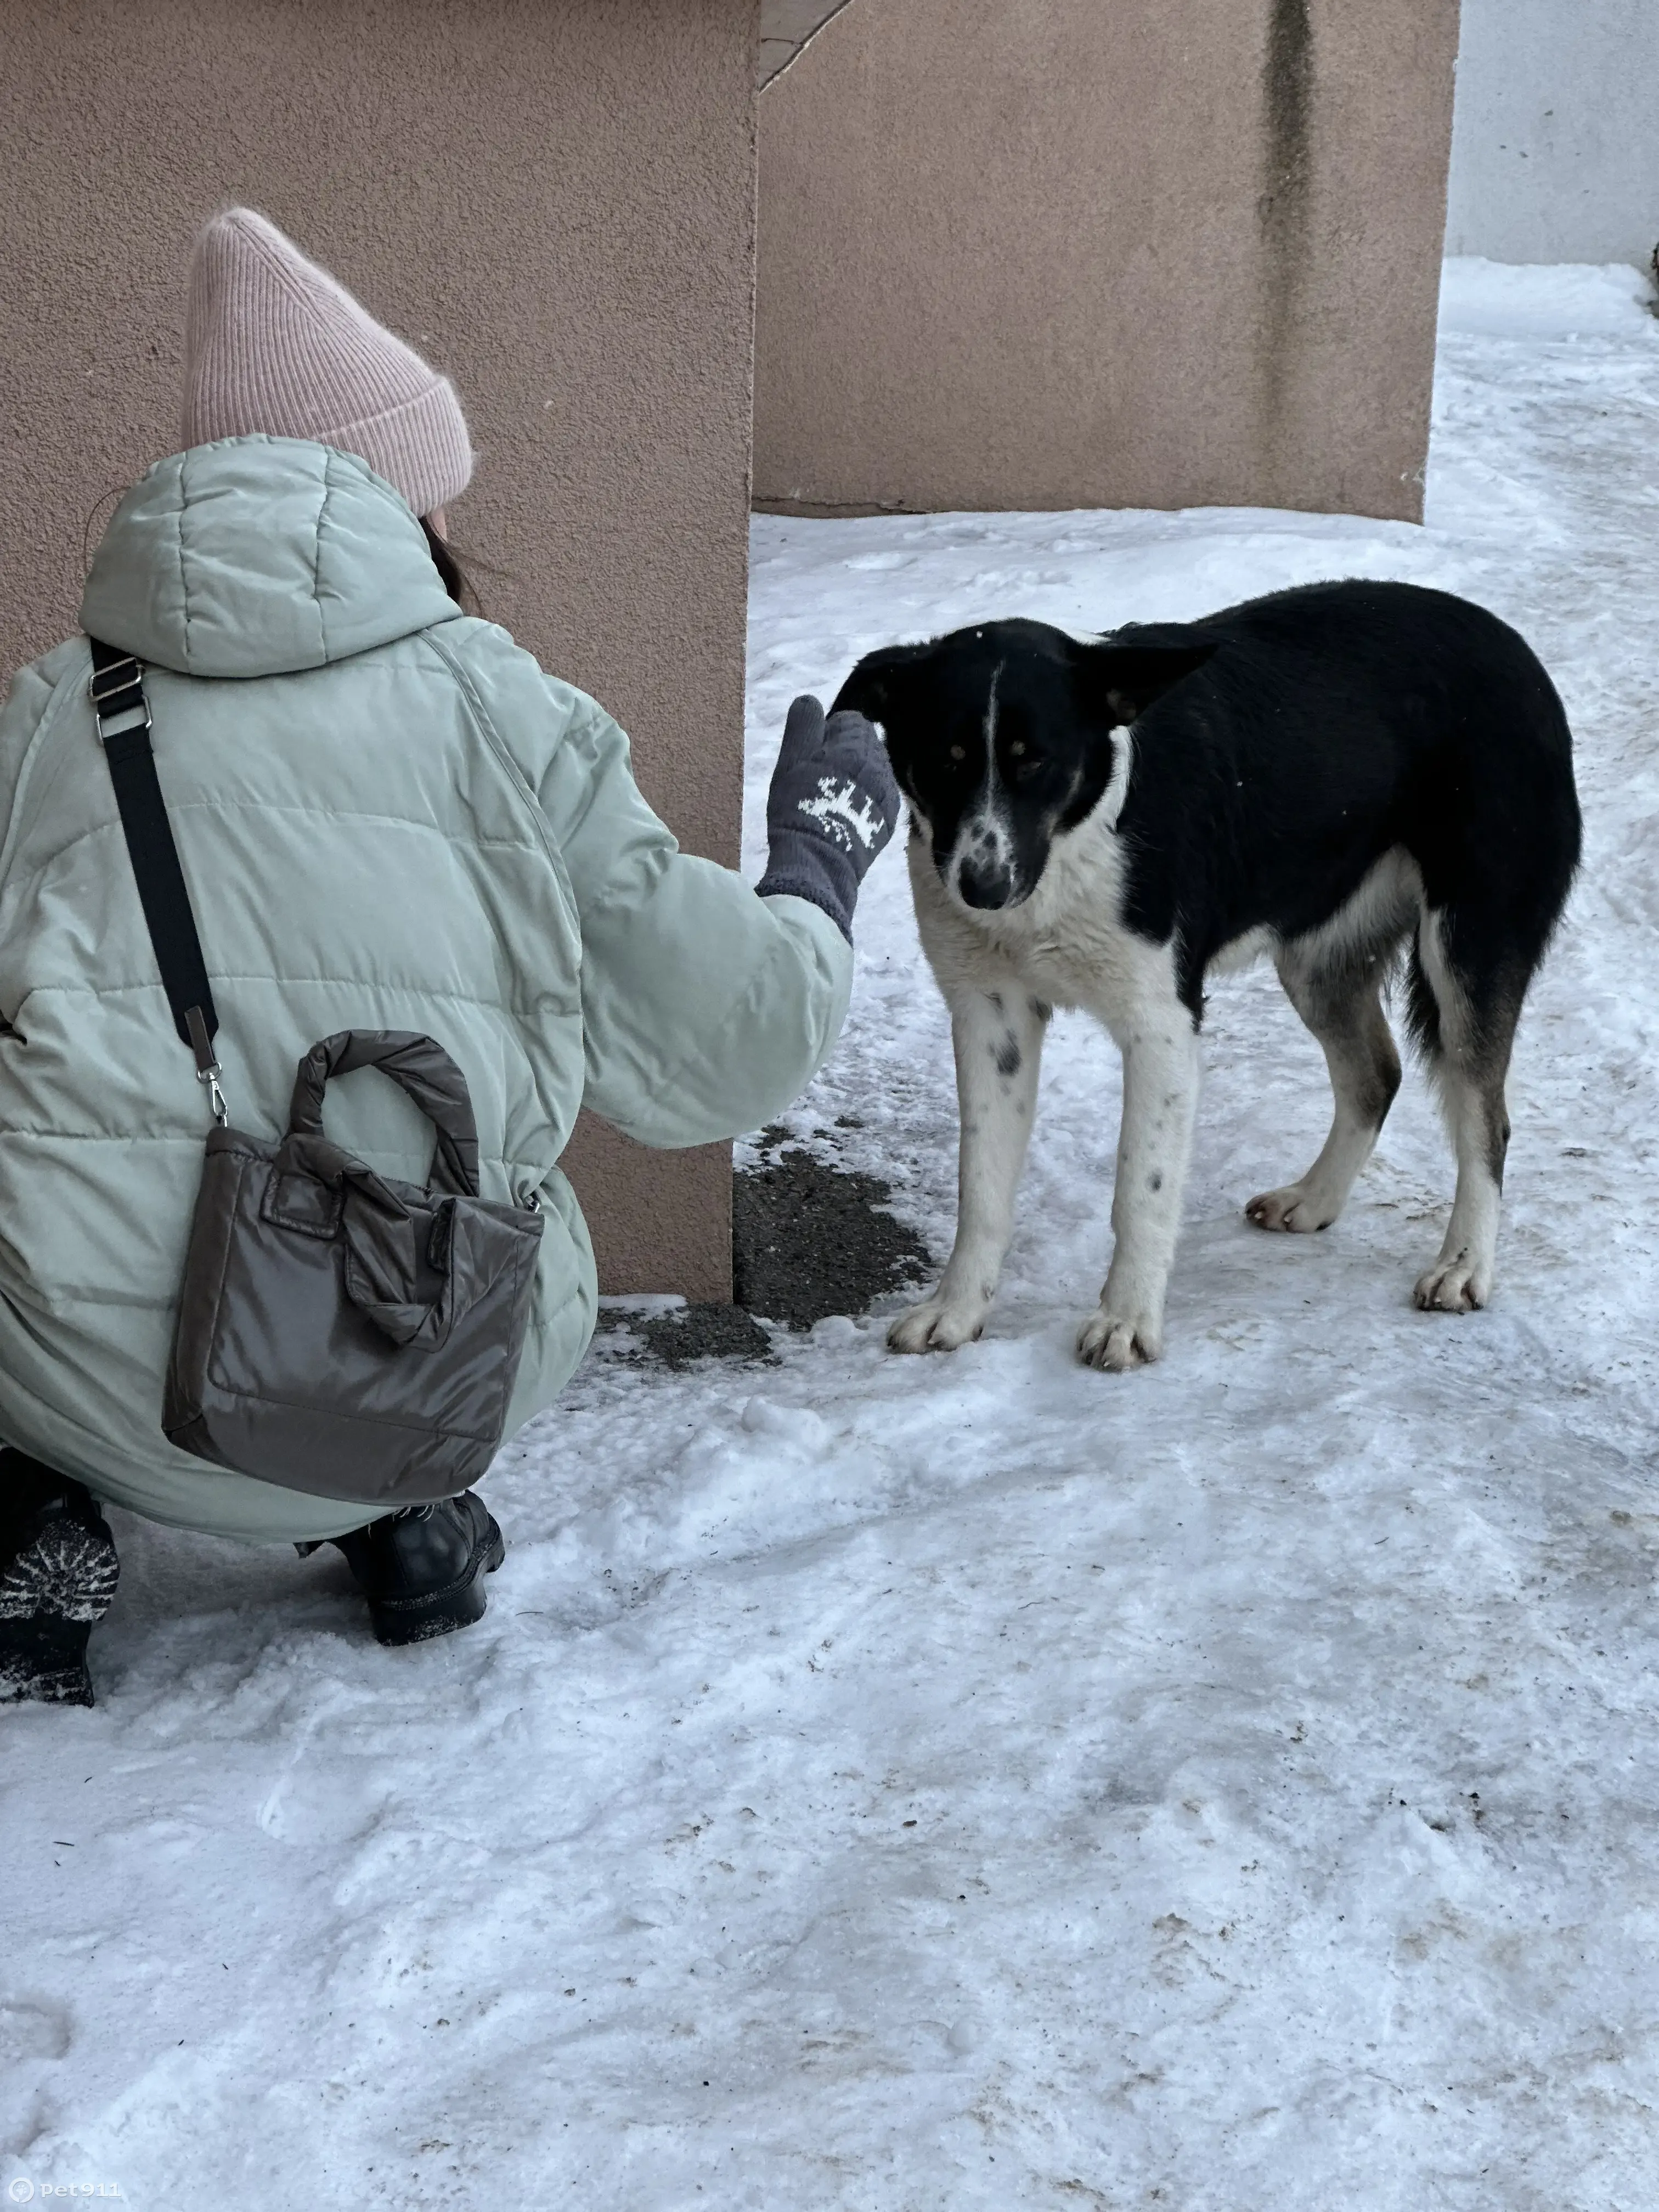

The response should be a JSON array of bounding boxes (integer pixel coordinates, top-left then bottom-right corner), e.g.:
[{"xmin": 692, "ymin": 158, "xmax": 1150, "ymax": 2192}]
[{"xmin": 88, "ymin": 637, "xmax": 228, "ymax": 1124}]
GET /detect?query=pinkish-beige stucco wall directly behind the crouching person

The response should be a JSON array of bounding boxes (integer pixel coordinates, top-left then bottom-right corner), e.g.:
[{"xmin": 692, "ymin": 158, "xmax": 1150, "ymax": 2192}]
[{"xmin": 0, "ymin": 0, "xmax": 759, "ymax": 1296}]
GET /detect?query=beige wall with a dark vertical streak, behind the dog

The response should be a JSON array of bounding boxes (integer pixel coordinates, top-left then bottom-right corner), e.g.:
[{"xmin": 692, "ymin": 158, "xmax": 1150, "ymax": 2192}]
[{"xmin": 754, "ymin": 0, "xmax": 1458, "ymax": 517}]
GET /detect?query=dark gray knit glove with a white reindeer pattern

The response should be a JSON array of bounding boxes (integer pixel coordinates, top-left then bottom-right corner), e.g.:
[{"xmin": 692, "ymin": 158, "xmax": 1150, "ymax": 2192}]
[{"xmin": 757, "ymin": 697, "xmax": 898, "ymax": 943}]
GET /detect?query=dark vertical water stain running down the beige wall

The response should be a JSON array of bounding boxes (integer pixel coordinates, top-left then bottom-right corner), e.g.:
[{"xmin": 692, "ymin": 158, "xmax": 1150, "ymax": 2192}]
[{"xmin": 1256, "ymin": 0, "xmax": 1314, "ymax": 449}]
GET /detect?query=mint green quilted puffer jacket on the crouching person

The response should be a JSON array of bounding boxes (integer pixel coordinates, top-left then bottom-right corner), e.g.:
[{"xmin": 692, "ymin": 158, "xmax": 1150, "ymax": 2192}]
[{"xmin": 0, "ymin": 438, "xmax": 851, "ymax": 1539}]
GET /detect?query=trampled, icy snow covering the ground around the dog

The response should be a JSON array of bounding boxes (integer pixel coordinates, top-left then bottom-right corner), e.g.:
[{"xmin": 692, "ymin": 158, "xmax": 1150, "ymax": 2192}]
[{"xmin": 0, "ymin": 263, "xmax": 1659, "ymax": 2212}]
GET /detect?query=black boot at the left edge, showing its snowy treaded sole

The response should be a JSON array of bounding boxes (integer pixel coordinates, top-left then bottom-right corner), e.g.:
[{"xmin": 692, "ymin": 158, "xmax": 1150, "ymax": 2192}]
[{"xmin": 0, "ymin": 1449, "xmax": 122, "ymax": 1706}]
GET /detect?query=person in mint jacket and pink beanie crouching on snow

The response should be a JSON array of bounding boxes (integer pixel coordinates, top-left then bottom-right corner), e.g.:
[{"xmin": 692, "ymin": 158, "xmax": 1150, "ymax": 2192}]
[{"xmin": 0, "ymin": 210, "xmax": 898, "ymax": 1703}]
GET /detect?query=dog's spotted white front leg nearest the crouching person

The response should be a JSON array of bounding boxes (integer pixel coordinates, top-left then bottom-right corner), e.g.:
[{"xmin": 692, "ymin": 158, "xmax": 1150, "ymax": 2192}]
[{"xmin": 887, "ymin": 982, "xmax": 1048, "ymax": 1352}]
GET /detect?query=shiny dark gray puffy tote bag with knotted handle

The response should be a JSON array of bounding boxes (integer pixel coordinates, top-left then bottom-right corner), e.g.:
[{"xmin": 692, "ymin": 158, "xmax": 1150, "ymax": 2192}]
[{"xmin": 161, "ymin": 1029, "xmax": 542, "ymax": 1509}]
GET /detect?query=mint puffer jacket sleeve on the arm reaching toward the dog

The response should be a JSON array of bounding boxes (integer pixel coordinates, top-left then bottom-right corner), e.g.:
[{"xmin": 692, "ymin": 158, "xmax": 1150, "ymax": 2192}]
[{"xmin": 538, "ymin": 679, "xmax": 851, "ymax": 1146}]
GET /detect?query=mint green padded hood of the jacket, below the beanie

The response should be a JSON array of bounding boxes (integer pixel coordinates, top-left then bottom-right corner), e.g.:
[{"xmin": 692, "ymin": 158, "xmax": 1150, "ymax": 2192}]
[{"xmin": 80, "ymin": 436, "xmax": 460, "ymax": 677}]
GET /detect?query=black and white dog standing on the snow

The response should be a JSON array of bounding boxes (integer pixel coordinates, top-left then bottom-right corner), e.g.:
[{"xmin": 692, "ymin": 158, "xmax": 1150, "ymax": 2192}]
[{"xmin": 836, "ymin": 582, "xmax": 1579, "ymax": 1369}]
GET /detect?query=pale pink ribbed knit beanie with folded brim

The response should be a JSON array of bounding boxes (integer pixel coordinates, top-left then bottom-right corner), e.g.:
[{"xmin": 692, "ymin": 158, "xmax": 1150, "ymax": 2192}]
[{"xmin": 184, "ymin": 208, "xmax": 473, "ymax": 515}]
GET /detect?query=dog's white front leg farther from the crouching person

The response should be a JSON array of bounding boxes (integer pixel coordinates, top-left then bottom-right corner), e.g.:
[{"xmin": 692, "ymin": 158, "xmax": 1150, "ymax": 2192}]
[{"xmin": 1077, "ymin": 1005, "xmax": 1199, "ymax": 1374}]
